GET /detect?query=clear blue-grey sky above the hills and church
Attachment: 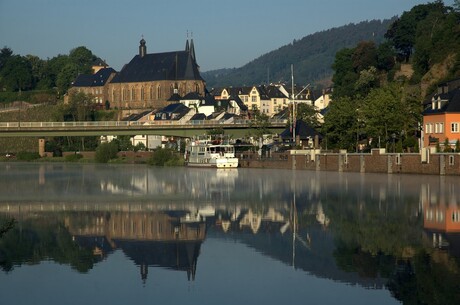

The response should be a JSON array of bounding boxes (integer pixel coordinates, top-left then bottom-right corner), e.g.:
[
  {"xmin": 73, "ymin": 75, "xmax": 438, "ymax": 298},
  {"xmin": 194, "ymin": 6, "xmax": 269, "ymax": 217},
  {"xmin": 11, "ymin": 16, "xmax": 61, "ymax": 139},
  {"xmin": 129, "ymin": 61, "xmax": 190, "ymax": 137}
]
[{"xmin": 0, "ymin": 0, "xmax": 454, "ymax": 71}]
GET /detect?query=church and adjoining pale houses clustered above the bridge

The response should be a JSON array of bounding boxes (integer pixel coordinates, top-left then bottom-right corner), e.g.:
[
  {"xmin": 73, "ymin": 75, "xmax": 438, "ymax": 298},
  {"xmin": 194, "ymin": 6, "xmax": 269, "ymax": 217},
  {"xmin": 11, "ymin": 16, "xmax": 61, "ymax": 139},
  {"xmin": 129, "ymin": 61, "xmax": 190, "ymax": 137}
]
[{"xmin": 69, "ymin": 39, "xmax": 331, "ymax": 121}]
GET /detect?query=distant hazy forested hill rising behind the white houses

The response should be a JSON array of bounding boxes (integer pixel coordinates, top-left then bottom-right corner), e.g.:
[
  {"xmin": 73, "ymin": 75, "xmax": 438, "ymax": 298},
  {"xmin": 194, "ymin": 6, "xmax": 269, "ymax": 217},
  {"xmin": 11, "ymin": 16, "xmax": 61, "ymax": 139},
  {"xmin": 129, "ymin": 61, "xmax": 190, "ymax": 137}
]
[{"xmin": 201, "ymin": 19, "xmax": 394, "ymax": 88}]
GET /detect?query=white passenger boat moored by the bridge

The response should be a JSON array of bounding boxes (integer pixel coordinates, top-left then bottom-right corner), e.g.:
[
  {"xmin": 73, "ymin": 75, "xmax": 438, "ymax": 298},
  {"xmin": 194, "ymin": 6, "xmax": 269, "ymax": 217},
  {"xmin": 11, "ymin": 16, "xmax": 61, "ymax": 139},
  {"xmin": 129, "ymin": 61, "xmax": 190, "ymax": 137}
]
[{"xmin": 185, "ymin": 136, "xmax": 238, "ymax": 168}]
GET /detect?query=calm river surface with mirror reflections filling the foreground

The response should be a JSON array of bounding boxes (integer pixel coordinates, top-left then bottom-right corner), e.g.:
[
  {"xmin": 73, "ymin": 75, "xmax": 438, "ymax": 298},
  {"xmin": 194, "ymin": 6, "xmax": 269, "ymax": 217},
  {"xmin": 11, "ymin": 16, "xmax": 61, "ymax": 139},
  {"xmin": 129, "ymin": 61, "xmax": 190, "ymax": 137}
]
[{"xmin": 0, "ymin": 163, "xmax": 460, "ymax": 305}]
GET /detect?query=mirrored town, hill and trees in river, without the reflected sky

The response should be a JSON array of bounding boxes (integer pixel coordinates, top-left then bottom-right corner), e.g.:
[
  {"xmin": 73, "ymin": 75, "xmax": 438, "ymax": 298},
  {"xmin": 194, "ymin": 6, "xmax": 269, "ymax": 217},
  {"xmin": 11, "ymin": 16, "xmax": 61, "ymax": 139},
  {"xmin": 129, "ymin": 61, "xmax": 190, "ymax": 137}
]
[{"xmin": 0, "ymin": 163, "xmax": 460, "ymax": 304}]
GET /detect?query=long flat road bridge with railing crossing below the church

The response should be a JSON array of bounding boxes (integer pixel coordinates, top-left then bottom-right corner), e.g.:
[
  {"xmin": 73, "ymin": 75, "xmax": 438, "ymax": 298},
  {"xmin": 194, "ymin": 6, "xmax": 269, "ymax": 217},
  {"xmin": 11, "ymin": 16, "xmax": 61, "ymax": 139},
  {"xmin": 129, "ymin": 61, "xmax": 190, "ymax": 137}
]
[{"xmin": 0, "ymin": 120, "xmax": 287, "ymax": 138}]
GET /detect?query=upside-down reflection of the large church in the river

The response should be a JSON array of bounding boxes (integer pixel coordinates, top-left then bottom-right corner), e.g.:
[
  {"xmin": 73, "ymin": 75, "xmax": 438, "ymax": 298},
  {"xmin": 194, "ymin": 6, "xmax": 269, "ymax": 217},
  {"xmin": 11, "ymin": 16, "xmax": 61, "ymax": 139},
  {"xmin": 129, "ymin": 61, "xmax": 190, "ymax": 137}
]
[{"xmin": 65, "ymin": 211, "xmax": 206, "ymax": 281}]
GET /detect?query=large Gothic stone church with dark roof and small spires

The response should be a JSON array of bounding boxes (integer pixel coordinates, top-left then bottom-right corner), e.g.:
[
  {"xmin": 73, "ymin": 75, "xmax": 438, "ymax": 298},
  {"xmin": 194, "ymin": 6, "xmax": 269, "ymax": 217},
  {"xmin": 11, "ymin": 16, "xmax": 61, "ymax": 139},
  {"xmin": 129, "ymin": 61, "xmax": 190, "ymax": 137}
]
[{"xmin": 108, "ymin": 39, "xmax": 206, "ymax": 110}]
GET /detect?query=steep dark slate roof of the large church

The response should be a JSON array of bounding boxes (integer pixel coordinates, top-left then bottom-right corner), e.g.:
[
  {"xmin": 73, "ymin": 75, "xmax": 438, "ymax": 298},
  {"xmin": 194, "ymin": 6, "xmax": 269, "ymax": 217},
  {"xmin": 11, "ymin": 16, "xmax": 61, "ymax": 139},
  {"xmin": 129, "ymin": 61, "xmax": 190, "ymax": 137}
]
[{"xmin": 112, "ymin": 51, "xmax": 203, "ymax": 83}]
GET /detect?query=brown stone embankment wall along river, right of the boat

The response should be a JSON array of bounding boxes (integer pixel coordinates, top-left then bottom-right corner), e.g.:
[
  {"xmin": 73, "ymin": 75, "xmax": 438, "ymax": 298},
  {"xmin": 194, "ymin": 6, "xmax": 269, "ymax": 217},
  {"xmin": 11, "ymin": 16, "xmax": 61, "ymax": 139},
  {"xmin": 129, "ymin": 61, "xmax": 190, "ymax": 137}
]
[{"xmin": 238, "ymin": 149, "xmax": 460, "ymax": 175}]
